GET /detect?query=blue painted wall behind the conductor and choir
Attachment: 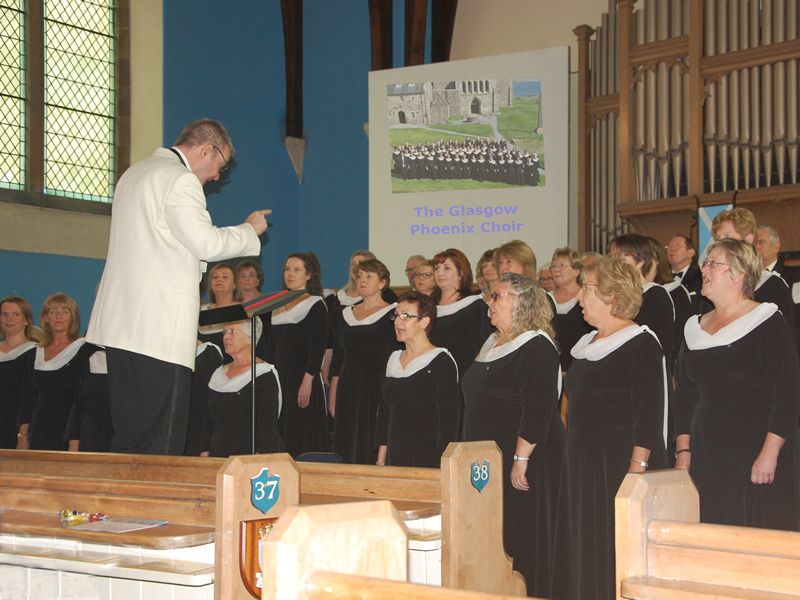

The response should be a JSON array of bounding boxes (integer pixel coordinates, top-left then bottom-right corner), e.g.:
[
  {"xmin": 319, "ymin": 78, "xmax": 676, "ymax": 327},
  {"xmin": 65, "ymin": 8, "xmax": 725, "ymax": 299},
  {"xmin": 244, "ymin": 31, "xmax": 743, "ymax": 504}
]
[{"xmin": 0, "ymin": 0, "xmax": 430, "ymax": 328}]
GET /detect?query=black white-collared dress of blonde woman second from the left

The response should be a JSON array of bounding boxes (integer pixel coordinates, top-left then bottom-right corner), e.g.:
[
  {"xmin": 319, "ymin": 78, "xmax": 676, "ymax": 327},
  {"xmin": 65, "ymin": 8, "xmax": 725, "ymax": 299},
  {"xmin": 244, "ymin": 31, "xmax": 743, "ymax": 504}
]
[{"xmin": 20, "ymin": 338, "xmax": 91, "ymax": 450}]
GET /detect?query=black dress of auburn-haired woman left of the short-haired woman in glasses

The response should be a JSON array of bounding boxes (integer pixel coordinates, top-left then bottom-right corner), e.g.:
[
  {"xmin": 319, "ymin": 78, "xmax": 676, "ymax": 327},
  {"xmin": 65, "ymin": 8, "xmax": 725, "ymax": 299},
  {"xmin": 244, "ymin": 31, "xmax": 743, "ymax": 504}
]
[{"xmin": 331, "ymin": 304, "xmax": 397, "ymax": 464}]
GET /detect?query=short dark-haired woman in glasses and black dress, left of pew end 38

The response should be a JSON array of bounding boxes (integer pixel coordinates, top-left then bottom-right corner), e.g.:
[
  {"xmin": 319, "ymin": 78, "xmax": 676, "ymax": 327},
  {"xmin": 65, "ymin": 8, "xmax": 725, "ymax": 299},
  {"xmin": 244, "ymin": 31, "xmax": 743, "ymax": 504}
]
[{"xmin": 377, "ymin": 292, "xmax": 460, "ymax": 468}]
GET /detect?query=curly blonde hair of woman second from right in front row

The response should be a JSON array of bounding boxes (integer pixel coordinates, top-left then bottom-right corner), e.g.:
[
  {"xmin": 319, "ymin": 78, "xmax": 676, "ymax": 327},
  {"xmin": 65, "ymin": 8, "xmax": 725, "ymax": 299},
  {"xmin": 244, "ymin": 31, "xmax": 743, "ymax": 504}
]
[{"xmin": 583, "ymin": 256, "xmax": 643, "ymax": 319}]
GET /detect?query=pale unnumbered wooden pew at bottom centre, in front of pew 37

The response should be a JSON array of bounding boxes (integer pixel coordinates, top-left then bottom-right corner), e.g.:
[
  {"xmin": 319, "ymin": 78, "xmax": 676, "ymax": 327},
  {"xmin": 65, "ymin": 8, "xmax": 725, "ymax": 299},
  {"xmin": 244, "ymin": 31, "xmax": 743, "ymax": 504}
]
[{"xmin": 261, "ymin": 501, "xmax": 536, "ymax": 600}]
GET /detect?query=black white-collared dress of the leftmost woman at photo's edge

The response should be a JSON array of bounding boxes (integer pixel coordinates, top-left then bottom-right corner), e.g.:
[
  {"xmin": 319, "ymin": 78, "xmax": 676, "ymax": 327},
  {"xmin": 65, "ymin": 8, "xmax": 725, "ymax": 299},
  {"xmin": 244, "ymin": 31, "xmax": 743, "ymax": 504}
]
[{"xmin": 0, "ymin": 342, "xmax": 36, "ymax": 448}]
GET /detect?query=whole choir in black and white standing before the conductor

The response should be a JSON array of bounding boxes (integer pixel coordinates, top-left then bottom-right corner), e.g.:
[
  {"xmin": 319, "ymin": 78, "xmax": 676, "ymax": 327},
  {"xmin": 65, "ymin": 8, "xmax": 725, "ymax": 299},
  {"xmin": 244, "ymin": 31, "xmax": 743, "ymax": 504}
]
[{"xmin": 0, "ymin": 204, "xmax": 800, "ymax": 599}]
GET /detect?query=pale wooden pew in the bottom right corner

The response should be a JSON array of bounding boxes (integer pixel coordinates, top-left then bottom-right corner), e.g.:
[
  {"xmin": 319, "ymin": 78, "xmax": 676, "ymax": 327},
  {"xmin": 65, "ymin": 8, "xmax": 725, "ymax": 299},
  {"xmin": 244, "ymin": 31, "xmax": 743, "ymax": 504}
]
[{"xmin": 615, "ymin": 469, "xmax": 800, "ymax": 600}]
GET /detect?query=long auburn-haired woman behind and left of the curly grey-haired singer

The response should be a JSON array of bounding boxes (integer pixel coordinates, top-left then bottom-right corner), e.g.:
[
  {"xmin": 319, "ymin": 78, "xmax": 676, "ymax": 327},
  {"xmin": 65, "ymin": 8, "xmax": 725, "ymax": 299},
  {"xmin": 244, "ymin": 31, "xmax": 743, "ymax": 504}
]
[{"xmin": 430, "ymin": 248, "xmax": 491, "ymax": 384}]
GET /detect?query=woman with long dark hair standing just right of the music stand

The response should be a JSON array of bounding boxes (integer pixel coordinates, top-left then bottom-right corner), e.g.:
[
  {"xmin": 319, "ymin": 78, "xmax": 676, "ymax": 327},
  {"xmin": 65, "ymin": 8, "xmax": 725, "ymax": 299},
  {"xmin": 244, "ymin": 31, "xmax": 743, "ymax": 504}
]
[{"xmin": 267, "ymin": 252, "xmax": 328, "ymax": 456}]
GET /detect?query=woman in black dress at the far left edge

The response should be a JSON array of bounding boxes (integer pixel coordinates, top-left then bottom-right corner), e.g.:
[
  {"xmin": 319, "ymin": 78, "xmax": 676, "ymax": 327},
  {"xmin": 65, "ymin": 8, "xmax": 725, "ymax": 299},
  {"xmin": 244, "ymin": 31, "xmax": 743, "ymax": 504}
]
[{"xmin": 0, "ymin": 296, "xmax": 36, "ymax": 448}]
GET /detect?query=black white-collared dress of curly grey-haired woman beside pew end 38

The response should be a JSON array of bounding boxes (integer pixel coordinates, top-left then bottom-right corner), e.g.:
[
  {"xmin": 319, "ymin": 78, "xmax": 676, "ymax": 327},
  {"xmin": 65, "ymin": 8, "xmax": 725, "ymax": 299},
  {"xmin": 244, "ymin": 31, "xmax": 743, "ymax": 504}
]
[{"xmin": 462, "ymin": 331, "xmax": 564, "ymax": 596}]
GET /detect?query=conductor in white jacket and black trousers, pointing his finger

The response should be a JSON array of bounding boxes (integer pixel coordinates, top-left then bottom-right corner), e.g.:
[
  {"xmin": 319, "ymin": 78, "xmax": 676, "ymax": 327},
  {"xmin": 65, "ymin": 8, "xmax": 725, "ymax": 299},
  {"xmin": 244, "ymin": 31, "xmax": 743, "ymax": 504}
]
[{"xmin": 86, "ymin": 119, "xmax": 271, "ymax": 454}]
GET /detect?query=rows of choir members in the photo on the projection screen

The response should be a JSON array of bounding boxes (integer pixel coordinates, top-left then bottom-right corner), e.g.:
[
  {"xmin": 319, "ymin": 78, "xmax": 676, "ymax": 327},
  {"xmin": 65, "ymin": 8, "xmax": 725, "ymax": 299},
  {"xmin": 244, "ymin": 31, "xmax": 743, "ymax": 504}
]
[{"xmin": 392, "ymin": 138, "xmax": 541, "ymax": 186}]
